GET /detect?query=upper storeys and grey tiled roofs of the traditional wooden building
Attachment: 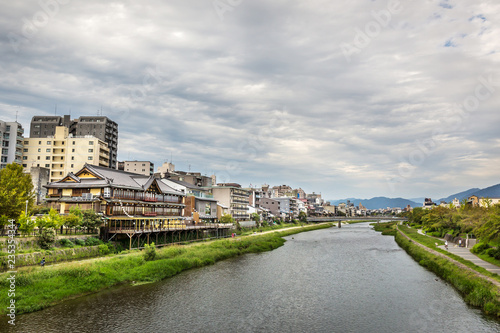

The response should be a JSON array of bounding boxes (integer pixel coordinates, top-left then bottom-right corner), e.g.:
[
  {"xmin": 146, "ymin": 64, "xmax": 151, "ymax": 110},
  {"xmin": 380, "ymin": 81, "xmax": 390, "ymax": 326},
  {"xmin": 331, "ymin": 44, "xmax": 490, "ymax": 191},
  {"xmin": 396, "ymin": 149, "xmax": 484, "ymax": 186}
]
[{"xmin": 46, "ymin": 164, "xmax": 184, "ymax": 219}]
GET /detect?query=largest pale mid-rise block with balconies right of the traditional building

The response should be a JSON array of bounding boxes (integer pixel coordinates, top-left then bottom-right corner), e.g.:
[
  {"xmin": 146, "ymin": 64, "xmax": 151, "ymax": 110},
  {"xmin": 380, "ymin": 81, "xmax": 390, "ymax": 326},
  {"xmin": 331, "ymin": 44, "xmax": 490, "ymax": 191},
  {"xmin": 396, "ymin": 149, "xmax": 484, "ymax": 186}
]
[{"xmin": 211, "ymin": 183, "xmax": 250, "ymax": 221}]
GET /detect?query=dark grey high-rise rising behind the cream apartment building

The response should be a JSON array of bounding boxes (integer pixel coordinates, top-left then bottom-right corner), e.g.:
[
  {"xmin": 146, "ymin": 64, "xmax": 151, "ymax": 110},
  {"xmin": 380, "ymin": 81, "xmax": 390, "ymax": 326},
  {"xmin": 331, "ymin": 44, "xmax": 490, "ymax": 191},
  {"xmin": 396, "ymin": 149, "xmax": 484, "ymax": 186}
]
[{"xmin": 30, "ymin": 115, "xmax": 118, "ymax": 169}]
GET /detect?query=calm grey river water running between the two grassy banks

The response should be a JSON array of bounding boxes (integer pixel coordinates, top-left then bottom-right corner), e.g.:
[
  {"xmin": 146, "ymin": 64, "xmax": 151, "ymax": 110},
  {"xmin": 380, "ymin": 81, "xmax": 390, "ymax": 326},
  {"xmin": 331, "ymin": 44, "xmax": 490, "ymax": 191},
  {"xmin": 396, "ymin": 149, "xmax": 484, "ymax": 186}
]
[{"xmin": 0, "ymin": 223, "xmax": 500, "ymax": 332}]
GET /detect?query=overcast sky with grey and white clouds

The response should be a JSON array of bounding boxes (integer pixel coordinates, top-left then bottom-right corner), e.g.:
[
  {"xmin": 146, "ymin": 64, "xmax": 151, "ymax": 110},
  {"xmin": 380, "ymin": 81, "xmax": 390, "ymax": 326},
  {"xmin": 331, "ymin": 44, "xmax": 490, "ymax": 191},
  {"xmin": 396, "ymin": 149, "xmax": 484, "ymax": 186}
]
[{"xmin": 0, "ymin": 0, "xmax": 500, "ymax": 199}]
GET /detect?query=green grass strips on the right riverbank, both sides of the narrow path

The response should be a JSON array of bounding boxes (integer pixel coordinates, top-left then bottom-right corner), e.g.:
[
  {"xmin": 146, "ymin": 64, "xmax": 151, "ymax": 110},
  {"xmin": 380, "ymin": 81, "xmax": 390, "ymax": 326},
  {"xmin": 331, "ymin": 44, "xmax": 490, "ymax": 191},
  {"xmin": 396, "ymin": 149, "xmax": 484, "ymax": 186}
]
[{"xmin": 375, "ymin": 222, "xmax": 500, "ymax": 318}]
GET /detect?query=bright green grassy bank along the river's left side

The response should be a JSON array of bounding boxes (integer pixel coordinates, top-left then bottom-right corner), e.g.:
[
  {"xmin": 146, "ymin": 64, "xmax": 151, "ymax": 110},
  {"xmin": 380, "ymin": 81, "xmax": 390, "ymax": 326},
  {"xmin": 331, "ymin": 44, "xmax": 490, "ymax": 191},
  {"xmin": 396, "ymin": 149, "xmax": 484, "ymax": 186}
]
[{"xmin": 0, "ymin": 224, "xmax": 332, "ymax": 314}]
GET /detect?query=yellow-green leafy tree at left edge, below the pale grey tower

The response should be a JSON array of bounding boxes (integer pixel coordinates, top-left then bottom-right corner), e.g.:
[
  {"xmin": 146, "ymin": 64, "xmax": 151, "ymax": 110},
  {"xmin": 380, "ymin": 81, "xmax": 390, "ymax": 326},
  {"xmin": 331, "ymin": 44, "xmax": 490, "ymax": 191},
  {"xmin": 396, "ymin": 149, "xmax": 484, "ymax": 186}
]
[{"xmin": 0, "ymin": 163, "xmax": 34, "ymax": 219}]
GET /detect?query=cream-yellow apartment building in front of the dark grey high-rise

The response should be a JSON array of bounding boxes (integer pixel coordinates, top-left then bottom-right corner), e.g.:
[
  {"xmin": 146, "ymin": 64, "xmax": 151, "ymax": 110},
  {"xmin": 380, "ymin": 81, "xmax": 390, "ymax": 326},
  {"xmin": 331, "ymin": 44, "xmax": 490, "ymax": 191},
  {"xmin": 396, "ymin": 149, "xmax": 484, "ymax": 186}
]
[{"xmin": 22, "ymin": 126, "xmax": 109, "ymax": 182}]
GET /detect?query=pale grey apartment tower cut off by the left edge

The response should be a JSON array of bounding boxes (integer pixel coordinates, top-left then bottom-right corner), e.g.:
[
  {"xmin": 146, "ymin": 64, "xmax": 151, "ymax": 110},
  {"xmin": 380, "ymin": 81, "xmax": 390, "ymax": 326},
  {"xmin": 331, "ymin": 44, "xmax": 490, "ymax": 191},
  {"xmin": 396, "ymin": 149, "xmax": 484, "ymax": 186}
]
[{"xmin": 0, "ymin": 120, "xmax": 24, "ymax": 169}]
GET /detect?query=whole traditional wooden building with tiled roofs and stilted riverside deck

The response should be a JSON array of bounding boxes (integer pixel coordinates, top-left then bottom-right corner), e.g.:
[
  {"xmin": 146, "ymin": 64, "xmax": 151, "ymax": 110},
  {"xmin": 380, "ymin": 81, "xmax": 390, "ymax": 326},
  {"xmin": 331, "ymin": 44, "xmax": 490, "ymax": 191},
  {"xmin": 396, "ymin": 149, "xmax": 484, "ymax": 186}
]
[{"xmin": 46, "ymin": 164, "xmax": 229, "ymax": 248}]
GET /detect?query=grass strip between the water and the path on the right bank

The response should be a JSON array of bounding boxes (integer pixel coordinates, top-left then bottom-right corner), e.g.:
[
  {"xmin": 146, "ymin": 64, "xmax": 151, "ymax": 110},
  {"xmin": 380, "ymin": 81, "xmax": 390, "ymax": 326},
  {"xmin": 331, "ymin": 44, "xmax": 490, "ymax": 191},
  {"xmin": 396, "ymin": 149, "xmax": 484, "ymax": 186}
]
[{"xmin": 395, "ymin": 228, "xmax": 500, "ymax": 318}]
